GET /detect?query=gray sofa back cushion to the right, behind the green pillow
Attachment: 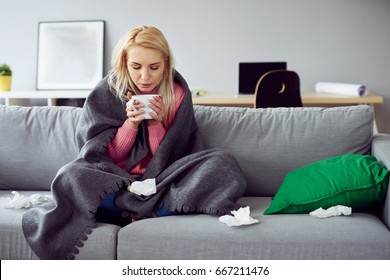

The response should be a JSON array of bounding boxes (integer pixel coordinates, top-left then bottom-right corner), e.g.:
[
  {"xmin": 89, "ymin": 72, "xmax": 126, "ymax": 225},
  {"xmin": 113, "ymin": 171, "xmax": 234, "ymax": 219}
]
[{"xmin": 195, "ymin": 105, "xmax": 373, "ymax": 196}]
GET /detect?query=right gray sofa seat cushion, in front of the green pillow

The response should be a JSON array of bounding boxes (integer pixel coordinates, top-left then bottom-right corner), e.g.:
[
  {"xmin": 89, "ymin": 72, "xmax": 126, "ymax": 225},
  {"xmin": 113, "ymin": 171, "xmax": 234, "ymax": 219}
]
[{"xmin": 118, "ymin": 197, "xmax": 390, "ymax": 260}]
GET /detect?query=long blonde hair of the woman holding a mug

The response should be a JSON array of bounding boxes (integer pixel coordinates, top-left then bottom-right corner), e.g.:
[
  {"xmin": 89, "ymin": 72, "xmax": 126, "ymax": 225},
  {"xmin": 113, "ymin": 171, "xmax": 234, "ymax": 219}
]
[{"xmin": 108, "ymin": 26, "xmax": 175, "ymax": 124}]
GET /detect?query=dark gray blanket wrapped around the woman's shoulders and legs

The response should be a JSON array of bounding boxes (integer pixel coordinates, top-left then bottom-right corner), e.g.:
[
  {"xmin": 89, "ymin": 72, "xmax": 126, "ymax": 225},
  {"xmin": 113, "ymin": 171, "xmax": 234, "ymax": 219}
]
[{"xmin": 22, "ymin": 72, "xmax": 246, "ymax": 259}]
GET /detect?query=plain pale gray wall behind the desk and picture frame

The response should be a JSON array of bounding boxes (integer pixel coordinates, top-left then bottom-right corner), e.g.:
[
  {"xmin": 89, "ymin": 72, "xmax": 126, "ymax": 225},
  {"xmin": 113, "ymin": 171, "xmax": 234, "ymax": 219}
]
[{"xmin": 0, "ymin": 0, "xmax": 390, "ymax": 133}]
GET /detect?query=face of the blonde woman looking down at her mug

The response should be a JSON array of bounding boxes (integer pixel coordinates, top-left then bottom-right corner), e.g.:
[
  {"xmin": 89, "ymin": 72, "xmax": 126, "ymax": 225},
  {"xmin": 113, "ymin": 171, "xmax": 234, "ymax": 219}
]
[{"xmin": 127, "ymin": 46, "xmax": 165, "ymax": 92}]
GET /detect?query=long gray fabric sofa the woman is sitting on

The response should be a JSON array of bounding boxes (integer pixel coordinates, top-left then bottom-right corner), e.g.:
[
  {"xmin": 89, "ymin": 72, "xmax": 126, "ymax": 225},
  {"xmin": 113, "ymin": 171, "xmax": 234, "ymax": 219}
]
[{"xmin": 0, "ymin": 105, "xmax": 390, "ymax": 260}]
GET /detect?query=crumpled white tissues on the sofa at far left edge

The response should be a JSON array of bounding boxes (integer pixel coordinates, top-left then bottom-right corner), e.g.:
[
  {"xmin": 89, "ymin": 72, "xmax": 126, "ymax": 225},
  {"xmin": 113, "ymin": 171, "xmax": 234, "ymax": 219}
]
[{"xmin": 0, "ymin": 191, "xmax": 53, "ymax": 209}]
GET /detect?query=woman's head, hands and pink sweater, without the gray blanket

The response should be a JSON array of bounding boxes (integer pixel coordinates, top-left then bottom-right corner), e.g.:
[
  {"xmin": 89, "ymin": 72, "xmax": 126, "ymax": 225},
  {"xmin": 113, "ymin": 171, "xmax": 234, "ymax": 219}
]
[{"xmin": 108, "ymin": 26, "xmax": 185, "ymax": 178}]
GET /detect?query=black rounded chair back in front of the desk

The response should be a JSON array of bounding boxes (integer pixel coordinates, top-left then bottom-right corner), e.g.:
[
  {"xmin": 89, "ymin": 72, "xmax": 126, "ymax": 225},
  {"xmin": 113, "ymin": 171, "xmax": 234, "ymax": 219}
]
[{"xmin": 254, "ymin": 70, "xmax": 303, "ymax": 108}]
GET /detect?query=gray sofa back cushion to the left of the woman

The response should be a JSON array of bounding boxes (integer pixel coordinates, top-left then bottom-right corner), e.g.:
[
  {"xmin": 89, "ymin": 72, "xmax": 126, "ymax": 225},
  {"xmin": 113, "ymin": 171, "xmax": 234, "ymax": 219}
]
[{"xmin": 0, "ymin": 105, "xmax": 81, "ymax": 190}]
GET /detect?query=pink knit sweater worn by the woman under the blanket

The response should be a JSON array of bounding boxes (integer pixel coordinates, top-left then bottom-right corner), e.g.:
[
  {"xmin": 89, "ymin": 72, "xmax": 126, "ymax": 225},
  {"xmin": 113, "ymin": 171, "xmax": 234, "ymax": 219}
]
[{"xmin": 107, "ymin": 83, "xmax": 185, "ymax": 178}]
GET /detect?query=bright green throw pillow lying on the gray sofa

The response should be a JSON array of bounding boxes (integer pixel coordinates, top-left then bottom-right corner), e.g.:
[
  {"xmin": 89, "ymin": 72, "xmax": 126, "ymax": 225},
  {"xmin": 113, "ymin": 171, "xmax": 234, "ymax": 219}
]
[{"xmin": 264, "ymin": 154, "xmax": 389, "ymax": 214}]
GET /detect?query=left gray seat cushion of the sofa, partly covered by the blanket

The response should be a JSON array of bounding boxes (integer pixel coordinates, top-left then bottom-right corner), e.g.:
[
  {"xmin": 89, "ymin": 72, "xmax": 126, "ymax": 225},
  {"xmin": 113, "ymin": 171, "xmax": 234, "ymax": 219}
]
[{"xmin": 0, "ymin": 191, "xmax": 120, "ymax": 260}]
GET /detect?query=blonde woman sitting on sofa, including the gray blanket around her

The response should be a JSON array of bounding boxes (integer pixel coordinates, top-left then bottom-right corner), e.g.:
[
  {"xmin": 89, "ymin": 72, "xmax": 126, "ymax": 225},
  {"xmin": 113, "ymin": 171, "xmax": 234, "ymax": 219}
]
[{"xmin": 23, "ymin": 26, "xmax": 246, "ymax": 259}]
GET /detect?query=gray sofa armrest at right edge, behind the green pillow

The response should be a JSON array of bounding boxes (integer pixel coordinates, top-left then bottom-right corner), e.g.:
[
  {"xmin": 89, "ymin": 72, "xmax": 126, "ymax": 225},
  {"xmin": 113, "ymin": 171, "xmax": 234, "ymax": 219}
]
[{"xmin": 371, "ymin": 134, "xmax": 390, "ymax": 229}]
